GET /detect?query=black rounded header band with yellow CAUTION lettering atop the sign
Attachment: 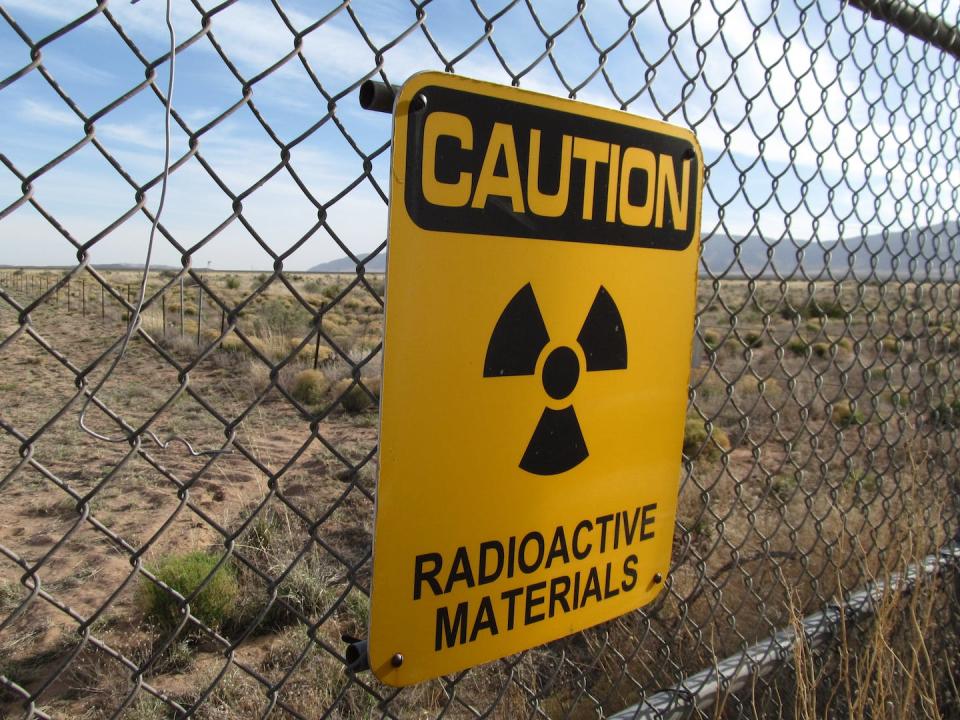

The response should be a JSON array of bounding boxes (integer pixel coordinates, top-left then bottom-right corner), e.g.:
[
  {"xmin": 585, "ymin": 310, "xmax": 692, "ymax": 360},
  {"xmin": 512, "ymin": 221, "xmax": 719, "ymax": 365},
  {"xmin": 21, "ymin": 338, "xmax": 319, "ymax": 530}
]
[{"xmin": 404, "ymin": 85, "xmax": 700, "ymax": 250}]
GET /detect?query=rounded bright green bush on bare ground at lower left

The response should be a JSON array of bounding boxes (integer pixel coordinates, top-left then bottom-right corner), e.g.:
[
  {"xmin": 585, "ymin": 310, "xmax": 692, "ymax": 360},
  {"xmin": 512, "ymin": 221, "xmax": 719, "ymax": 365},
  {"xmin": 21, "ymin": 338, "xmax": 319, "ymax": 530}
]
[{"xmin": 139, "ymin": 550, "xmax": 239, "ymax": 629}]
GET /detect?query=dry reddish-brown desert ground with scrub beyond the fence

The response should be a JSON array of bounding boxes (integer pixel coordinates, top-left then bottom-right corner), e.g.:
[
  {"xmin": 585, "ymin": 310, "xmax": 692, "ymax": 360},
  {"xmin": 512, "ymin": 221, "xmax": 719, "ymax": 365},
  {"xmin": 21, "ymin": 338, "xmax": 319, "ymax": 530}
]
[{"xmin": 0, "ymin": 268, "xmax": 960, "ymax": 719}]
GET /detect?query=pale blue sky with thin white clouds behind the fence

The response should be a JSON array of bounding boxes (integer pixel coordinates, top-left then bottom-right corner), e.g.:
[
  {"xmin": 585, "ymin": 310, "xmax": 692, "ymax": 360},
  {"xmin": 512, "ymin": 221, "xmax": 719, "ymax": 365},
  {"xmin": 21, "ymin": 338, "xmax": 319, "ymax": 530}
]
[{"xmin": 0, "ymin": 0, "xmax": 960, "ymax": 270}]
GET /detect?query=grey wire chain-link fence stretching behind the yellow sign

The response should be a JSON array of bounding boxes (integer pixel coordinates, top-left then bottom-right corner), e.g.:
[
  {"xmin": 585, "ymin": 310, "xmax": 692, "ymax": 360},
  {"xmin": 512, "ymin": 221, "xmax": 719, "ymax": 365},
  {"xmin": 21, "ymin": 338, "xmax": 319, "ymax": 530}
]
[{"xmin": 0, "ymin": 0, "xmax": 960, "ymax": 718}]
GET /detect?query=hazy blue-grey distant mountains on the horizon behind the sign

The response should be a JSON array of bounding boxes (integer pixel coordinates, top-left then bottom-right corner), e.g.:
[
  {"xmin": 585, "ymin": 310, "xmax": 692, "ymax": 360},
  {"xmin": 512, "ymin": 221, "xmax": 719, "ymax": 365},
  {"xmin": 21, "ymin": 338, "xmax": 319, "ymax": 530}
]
[{"xmin": 308, "ymin": 221, "xmax": 960, "ymax": 280}]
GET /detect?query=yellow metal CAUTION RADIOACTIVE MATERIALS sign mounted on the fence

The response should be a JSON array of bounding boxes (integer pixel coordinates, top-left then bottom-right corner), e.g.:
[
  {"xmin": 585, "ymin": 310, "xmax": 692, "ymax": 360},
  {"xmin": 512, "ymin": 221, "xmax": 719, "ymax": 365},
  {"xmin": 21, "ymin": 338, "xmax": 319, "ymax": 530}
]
[{"xmin": 368, "ymin": 73, "xmax": 703, "ymax": 685}]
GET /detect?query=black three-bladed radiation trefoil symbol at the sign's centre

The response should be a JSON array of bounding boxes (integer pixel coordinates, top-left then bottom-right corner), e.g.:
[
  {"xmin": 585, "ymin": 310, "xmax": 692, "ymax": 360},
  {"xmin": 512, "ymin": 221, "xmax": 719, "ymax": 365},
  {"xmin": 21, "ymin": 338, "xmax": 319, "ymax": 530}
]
[{"xmin": 483, "ymin": 283, "xmax": 627, "ymax": 475}]
